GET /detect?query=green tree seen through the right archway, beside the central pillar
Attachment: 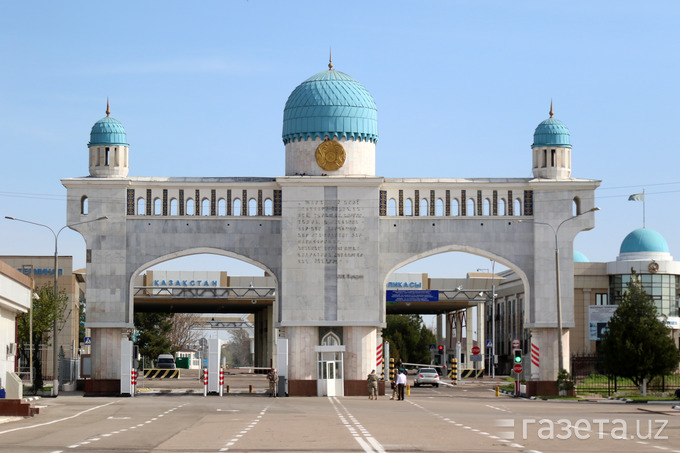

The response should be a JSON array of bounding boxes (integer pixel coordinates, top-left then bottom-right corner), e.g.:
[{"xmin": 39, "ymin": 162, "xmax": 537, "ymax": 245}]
[{"xmin": 382, "ymin": 315, "xmax": 436, "ymax": 363}]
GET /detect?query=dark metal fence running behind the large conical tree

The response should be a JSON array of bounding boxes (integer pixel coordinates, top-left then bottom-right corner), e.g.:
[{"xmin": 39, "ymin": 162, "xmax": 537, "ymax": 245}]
[{"xmin": 571, "ymin": 355, "xmax": 680, "ymax": 396}]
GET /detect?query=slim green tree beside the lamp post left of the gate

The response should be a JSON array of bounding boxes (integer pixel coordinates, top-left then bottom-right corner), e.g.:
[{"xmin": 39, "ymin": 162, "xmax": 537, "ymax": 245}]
[{"xmin": 17, "ymin": 283, "xmax": 68, "ymax": 394}]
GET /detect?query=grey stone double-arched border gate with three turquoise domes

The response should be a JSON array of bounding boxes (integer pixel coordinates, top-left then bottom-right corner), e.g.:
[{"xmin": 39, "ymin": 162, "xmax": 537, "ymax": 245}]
[{"xmin": 62, "ymin": 63, "xmax": 599, "ymax": 396}]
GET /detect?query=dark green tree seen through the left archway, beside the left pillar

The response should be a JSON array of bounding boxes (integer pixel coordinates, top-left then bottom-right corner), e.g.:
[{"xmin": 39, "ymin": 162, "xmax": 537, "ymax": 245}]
[{"xmin": 135, "ymin": 313, "xmax": 177, "ymax": 363}]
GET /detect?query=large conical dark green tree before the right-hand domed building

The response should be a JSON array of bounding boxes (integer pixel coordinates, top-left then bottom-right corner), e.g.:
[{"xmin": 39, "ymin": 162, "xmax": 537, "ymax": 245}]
[{"xmin": 600, "ymin": 270, "xmax": 680, "ymax": 395}]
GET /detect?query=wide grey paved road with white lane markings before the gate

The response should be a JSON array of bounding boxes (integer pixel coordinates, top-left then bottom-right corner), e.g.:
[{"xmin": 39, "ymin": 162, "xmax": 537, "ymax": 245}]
[{"xmin": 0, "ymin": 384, "xmax": 680, "ymax": 453}]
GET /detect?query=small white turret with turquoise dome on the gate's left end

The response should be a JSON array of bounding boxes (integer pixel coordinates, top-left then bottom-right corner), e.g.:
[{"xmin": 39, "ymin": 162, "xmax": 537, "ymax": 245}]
[{"xmin": 87, "ymin": 99, "xmax": 129, "ymax": 178}]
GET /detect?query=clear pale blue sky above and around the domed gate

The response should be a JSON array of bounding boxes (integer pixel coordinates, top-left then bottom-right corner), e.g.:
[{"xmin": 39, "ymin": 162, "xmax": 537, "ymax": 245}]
[{"xmin": 0, "ymin": 0, "xmax": 680, "ymax": 276}]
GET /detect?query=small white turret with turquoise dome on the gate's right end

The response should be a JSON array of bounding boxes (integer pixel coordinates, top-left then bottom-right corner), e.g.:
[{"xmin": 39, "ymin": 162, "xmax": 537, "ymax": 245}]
[{"xmin": 531, "ymin": 101, "xmax": 571, "ymax": 179}]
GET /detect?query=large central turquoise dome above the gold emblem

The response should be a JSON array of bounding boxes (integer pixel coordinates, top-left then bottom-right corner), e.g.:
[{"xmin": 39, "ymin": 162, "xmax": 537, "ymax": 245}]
[{"xmin": 282, "ymin": 65, "xmax": 378, "ymax": 143}]
